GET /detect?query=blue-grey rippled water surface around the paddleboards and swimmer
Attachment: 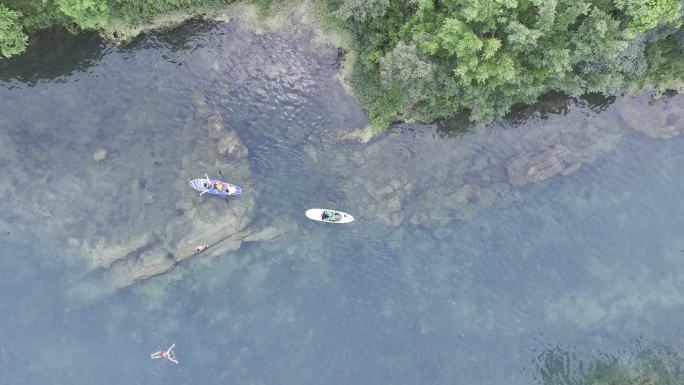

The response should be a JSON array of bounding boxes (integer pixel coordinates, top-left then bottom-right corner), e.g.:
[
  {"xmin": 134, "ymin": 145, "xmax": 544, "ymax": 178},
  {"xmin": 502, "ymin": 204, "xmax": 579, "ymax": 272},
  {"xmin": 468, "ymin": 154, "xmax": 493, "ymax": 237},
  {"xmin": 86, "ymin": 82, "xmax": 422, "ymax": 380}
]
[{"xmin": 0, "ymin": 17, "xmax": 684, "ymax": 385}]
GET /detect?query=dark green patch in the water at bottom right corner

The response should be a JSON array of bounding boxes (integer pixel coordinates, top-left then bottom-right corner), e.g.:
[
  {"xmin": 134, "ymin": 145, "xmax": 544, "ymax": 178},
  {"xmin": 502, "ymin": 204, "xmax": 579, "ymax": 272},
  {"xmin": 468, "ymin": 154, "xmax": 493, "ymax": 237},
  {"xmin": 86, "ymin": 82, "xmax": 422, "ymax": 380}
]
[{"xmin": 533, "ymin": 340, "xmax": 684, "ymax": 385}]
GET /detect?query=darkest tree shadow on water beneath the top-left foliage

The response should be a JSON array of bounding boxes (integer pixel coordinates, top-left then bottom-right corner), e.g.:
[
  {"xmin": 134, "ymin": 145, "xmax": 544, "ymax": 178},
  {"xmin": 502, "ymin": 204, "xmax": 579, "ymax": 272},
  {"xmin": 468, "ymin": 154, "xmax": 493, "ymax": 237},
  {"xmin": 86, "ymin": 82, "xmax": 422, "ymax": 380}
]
[{"xmin": 0, "ymin": 28, "xmax": 109, "ymax": 86}]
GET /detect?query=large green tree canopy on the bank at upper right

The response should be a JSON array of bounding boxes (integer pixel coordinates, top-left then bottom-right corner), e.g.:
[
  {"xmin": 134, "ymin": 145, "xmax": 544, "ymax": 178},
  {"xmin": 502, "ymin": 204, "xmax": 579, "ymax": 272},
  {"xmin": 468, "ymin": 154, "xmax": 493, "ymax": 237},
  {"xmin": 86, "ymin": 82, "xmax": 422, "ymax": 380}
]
[{"xmin": 327, "ymin": 0, "xmax": 684, "ymax": 124}]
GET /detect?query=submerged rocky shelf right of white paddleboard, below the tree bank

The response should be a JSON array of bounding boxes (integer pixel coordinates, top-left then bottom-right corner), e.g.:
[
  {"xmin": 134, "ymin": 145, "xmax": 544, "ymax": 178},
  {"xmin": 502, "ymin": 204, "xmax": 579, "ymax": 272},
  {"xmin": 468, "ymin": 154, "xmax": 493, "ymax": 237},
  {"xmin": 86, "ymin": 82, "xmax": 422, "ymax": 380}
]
[{"xmin": 314, "ymin": 97, "xmax": 623, "ymax": 232}]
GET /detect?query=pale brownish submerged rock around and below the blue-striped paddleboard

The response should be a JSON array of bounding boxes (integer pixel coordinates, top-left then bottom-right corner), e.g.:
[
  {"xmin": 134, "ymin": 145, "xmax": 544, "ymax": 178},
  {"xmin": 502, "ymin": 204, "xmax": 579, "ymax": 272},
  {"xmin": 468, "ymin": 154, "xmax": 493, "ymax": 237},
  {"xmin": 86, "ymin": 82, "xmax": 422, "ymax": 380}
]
[{"xmin": 54, "ymin": 93, "xmax": 272, "ymax": 302}]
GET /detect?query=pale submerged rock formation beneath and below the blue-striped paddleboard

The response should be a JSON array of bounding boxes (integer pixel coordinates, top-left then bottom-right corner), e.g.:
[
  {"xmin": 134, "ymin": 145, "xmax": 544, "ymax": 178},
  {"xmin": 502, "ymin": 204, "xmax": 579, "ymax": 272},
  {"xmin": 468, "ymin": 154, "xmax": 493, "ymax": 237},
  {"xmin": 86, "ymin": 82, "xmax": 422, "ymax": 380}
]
[{"xmin": 64, "ymin": 91, "xmax": 279, "ymax": 299}]
